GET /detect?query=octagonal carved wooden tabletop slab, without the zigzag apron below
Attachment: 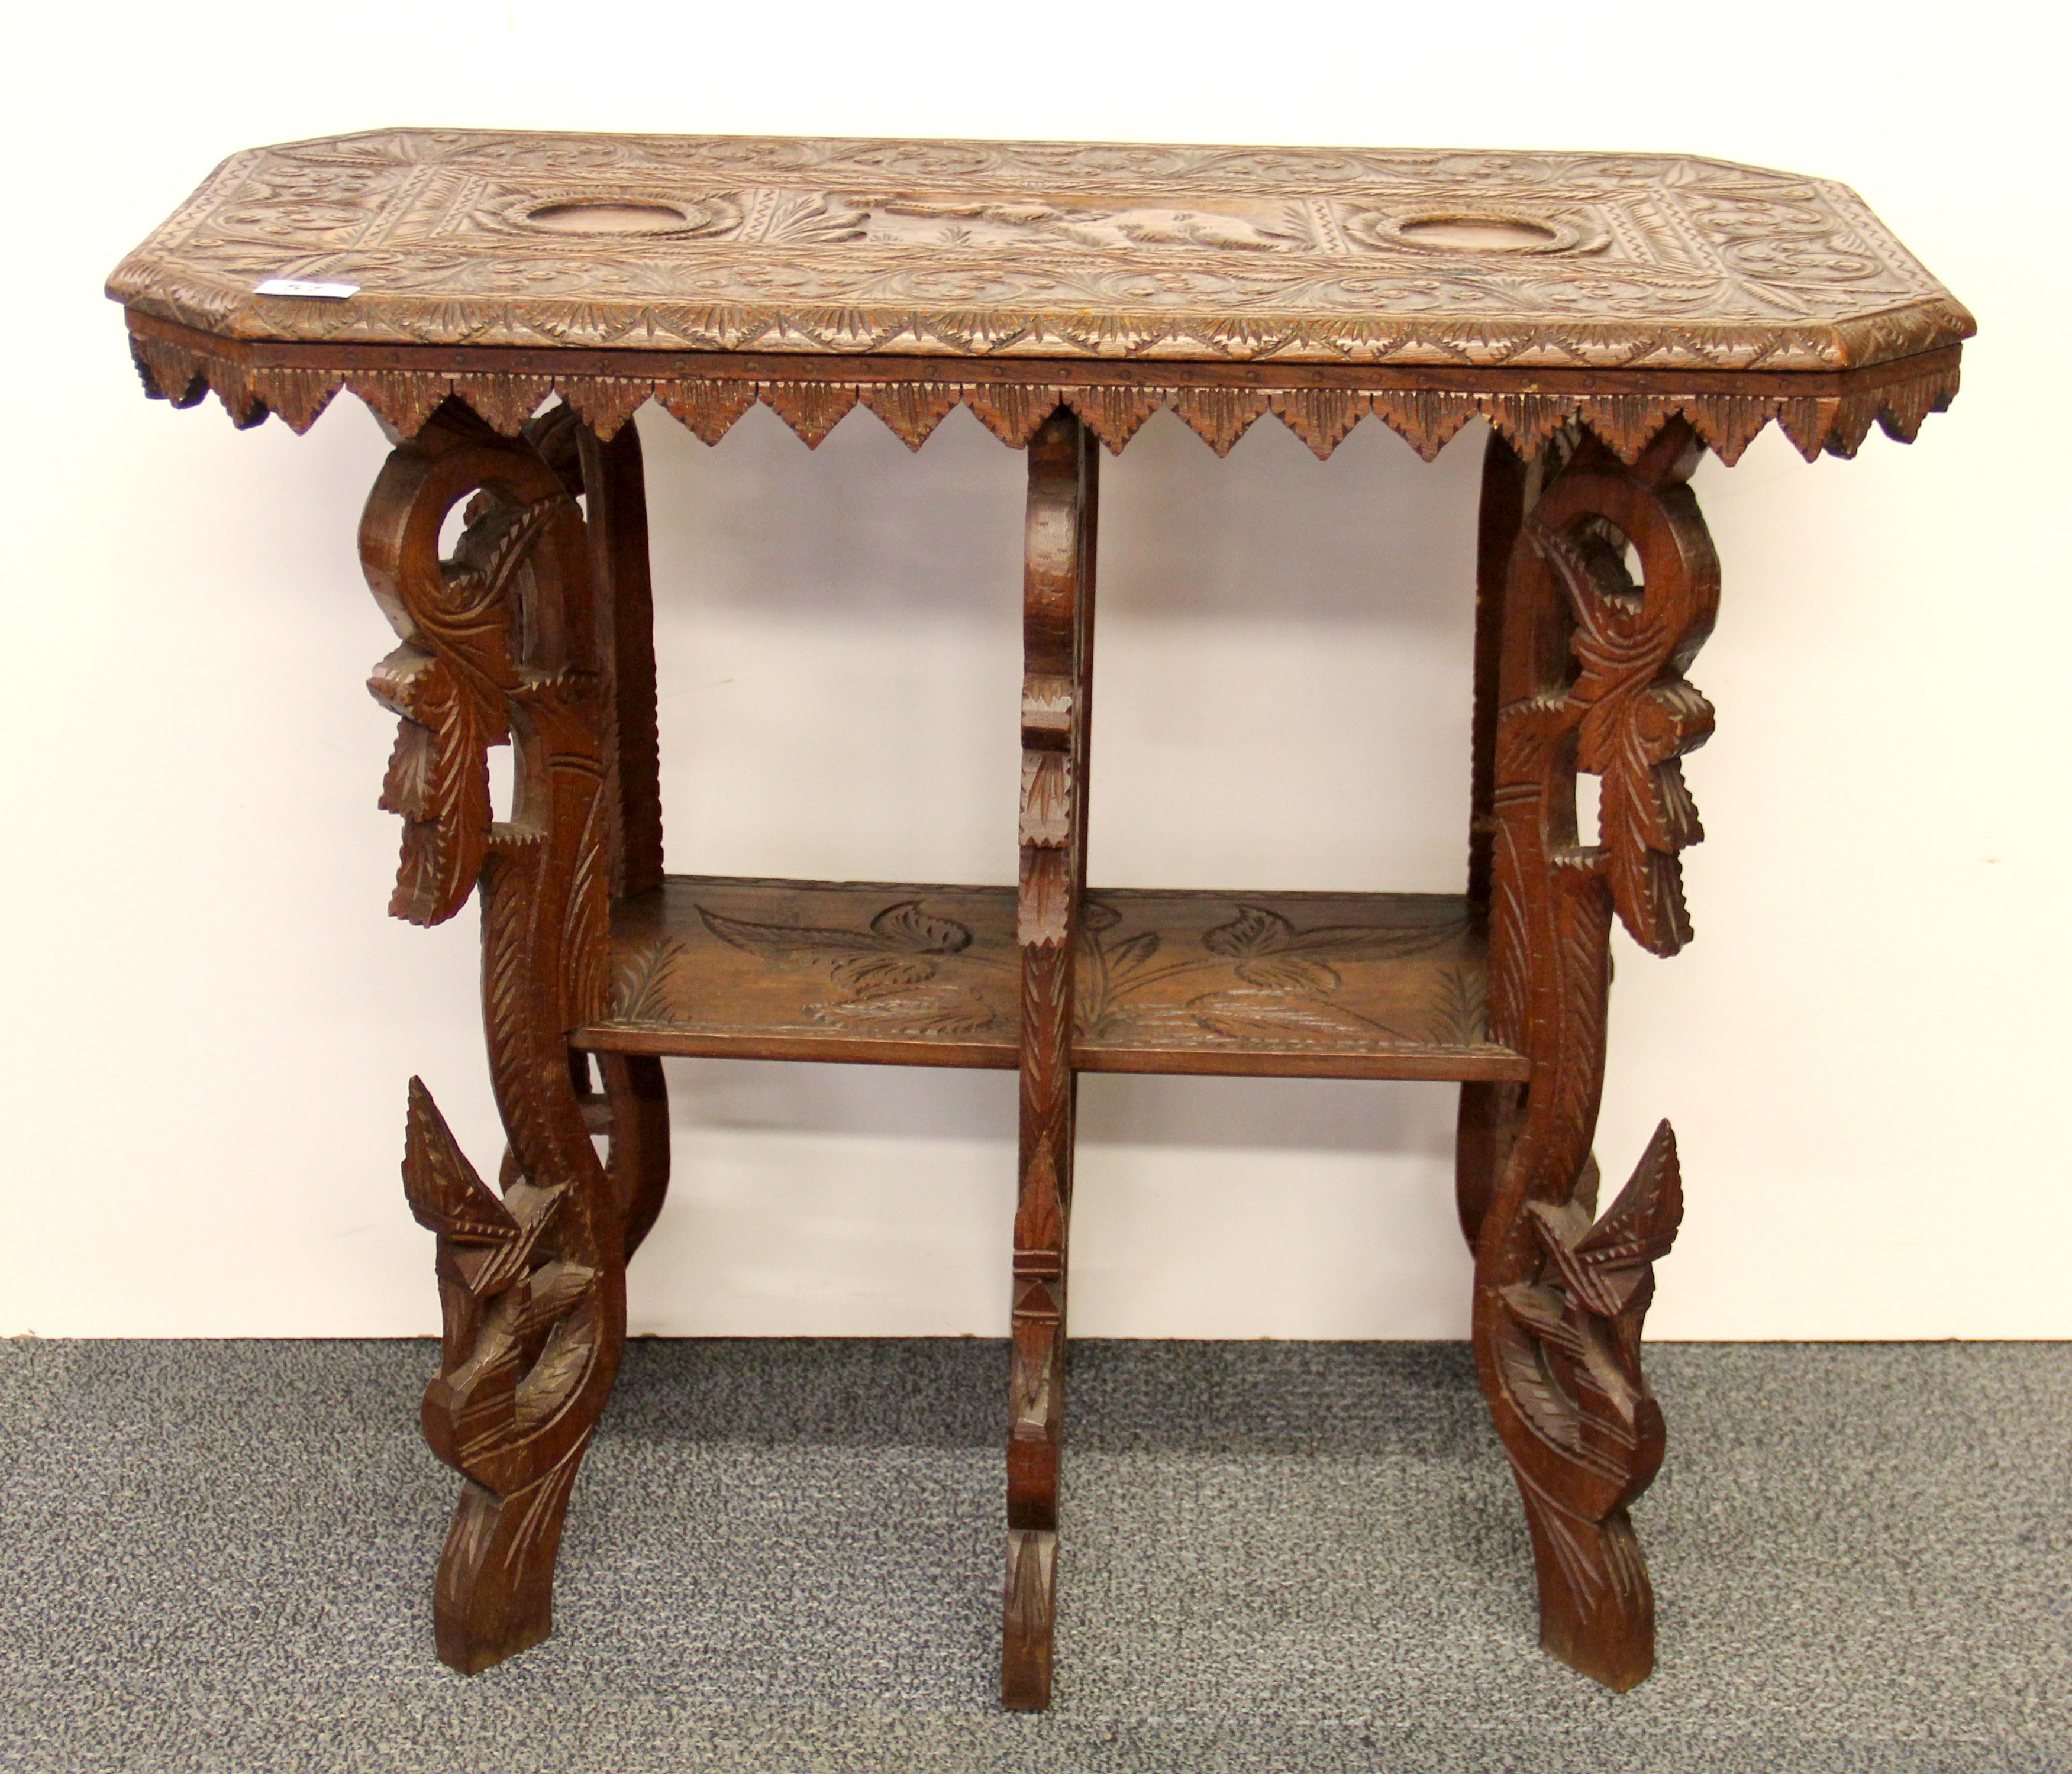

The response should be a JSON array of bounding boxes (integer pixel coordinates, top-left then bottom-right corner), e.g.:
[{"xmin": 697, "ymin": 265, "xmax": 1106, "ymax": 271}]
[{"xmin": 110, "ymin": 128, "xmax": 1973, "ymax": 373}]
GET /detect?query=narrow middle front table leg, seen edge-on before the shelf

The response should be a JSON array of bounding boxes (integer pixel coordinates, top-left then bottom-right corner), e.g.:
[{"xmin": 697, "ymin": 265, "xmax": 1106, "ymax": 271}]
[{"xmin": 1001, "ymin": 408, "xmax": 1098, "ymax": 1710}]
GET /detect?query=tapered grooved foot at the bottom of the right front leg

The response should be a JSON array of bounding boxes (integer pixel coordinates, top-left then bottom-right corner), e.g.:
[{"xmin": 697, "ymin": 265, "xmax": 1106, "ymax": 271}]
[{"xmin": 1519, "ymin": 1478, "xmax": 1655, "ymax": 1693}]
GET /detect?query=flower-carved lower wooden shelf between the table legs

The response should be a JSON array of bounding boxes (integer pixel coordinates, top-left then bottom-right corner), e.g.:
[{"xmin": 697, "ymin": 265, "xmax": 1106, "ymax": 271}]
[{"xmin": 574, "ymin": 874, "xmax": 1527, "ymax": 1080}]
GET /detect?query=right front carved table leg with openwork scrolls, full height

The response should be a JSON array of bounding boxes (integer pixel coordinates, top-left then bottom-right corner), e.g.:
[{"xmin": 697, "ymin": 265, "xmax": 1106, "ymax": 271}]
[{"xmin": 1475, "ymin": 419, "xmax": 1720, "ymax": 1689}]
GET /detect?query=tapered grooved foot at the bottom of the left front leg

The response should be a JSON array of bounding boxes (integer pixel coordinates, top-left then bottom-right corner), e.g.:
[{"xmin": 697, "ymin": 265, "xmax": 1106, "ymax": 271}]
[{"xmin": 431, "ymin": 1436, "xmax": 589, "ymax": 1675}]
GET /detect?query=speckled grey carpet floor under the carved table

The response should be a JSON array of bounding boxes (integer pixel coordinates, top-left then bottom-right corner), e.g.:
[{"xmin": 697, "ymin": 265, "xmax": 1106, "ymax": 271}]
[{"xmin": 0, "ymin": 1341, "xmax": 2072, "ymax": 1774}]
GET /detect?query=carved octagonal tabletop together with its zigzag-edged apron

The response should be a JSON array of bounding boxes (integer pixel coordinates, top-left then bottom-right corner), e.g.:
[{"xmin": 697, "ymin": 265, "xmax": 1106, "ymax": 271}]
[{"xmin": 108, "ymin": 131, "xmax": 1973, "ymax": 462}]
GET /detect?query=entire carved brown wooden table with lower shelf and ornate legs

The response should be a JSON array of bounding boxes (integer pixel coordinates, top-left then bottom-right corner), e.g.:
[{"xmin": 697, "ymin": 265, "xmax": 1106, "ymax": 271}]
[{"xmin": 110, "ymin": 131, "xmax": 1970, "ymax": 1708}]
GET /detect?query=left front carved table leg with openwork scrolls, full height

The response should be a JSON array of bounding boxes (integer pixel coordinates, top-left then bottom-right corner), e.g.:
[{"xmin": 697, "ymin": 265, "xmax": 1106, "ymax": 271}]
[{"xmin": 360, "ymin": 404, "xmax": 634, "ymax": 1675}]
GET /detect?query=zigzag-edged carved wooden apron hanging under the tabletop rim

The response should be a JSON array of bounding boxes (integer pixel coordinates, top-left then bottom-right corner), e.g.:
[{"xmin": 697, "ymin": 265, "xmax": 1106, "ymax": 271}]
[{"xmin": 131, "ymin": 315, "xmax": 1958, "ymax": 464}]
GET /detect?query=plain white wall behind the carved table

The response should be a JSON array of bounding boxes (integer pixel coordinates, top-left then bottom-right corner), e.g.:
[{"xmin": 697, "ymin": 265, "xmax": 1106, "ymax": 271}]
[{"xmin": 0, "ymin": 0, "xmax": 2072, "ymax": 1337}]
